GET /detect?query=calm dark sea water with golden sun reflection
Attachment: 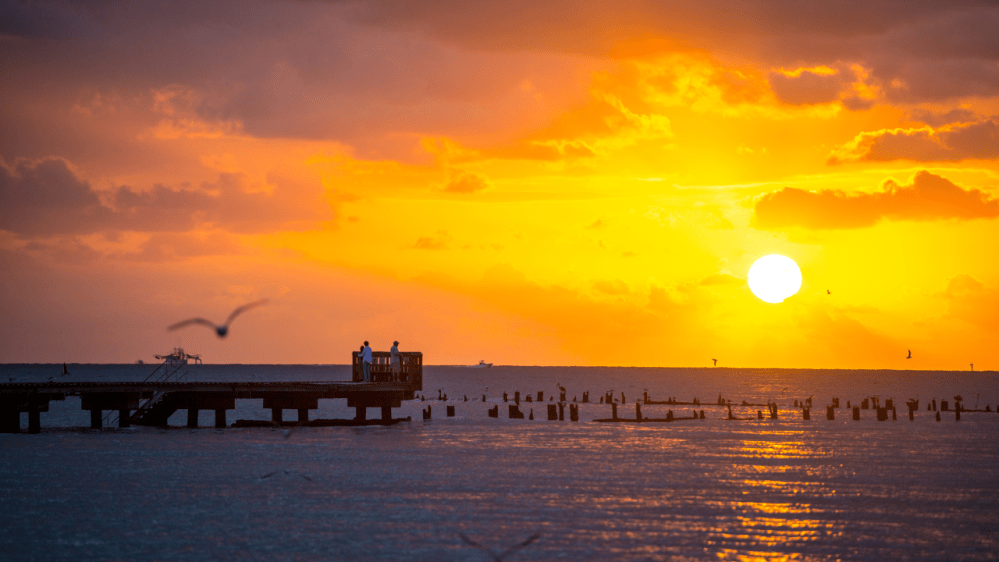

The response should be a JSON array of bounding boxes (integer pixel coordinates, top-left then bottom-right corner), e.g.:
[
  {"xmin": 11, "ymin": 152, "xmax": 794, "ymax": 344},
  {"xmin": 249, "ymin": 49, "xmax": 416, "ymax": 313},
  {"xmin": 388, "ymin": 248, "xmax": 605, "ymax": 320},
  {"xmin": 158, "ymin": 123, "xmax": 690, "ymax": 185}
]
[{"xmin": 0, "ymin": 364, "xmax": 999, "ymax": 561}]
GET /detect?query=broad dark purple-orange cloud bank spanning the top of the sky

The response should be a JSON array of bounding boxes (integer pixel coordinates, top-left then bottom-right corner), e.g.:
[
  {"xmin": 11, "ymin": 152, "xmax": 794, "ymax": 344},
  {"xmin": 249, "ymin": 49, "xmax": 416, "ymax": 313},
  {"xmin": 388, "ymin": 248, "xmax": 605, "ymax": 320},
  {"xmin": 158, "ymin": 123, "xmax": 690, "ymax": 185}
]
[{"xmin": 7, "ymin": 0, "xmax": 999, "ymax": 165}]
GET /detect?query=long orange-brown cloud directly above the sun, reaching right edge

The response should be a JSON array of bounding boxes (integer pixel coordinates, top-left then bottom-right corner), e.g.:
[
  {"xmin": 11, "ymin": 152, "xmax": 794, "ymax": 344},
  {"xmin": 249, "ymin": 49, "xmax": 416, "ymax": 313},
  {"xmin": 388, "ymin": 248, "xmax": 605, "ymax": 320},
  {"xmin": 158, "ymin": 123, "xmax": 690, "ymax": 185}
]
[{"xmin": 751, "ymin": 170, "xmax": 999, "ymax": 229}]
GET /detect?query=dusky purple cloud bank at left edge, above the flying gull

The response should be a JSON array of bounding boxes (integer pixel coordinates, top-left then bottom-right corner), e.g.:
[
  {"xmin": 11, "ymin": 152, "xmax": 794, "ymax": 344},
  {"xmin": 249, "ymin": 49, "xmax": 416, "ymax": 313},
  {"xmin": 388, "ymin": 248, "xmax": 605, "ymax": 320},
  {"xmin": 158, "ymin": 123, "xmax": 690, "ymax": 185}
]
[{"xmin": 0, "ymin": 158, "xmax": 333, "ymax": 236}]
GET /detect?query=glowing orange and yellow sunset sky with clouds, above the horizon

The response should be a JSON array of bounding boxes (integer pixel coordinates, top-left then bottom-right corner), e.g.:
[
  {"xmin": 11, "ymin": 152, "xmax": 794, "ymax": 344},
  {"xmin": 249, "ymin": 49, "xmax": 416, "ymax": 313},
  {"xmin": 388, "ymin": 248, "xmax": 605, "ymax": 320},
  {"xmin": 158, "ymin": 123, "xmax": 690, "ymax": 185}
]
[{"xmin": 0, "ymin": 0, "xmax": 999, "ymax": 370}]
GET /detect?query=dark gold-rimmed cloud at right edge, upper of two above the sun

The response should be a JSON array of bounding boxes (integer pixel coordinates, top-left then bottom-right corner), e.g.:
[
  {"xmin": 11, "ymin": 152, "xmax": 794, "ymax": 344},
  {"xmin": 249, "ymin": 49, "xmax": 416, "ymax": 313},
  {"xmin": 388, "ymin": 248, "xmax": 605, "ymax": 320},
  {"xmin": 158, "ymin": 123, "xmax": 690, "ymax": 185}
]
[{"xmin": 829, "ymin": 115, "xmax": 999, "ymax": 164}]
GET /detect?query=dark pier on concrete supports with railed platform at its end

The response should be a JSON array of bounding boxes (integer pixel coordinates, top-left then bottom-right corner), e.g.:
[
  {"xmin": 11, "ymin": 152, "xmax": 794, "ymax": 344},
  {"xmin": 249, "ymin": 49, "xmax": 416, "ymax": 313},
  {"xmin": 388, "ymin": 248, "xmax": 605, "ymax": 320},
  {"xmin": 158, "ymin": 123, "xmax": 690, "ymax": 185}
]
[{"xmin": 0, "ymin": 350, "xmax": 423, "ymax": 433}]
